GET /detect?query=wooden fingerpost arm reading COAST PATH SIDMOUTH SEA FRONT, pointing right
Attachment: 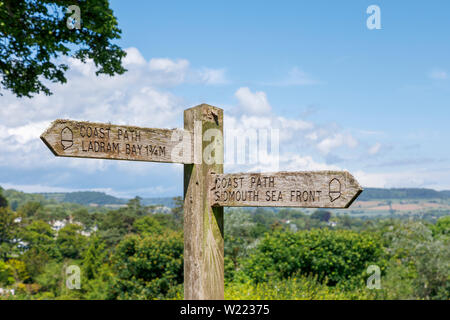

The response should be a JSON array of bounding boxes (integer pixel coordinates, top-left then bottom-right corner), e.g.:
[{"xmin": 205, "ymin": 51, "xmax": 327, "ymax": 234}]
[{"xmin": 209, "ymin": 171, "xmax": 363, "ymax": 208}]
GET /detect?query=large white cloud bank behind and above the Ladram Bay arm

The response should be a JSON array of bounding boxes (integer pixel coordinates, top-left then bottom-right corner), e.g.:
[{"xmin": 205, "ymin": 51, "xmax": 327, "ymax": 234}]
[{"xmin": 0, "ymin": 48, "xmax": 226, "ymax": 171}]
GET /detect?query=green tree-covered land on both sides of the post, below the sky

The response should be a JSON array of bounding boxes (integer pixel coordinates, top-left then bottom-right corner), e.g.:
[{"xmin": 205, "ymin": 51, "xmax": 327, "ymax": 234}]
[{"xmin": 0, "ymin": 186, "xmax": 450, "ymax": 300}]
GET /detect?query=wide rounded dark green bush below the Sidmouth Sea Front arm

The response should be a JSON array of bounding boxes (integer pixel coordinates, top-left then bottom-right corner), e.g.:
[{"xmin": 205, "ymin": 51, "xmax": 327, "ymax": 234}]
[{"xmin": 244, "ymin": 229, "xmax": 381, "ymax": 285}]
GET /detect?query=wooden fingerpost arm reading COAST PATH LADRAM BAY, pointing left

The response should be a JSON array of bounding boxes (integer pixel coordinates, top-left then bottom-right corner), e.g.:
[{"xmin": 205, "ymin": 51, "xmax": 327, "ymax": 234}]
[{"xmin": 41, "ymin": 120, "xmax": 193, "ymax": 163}]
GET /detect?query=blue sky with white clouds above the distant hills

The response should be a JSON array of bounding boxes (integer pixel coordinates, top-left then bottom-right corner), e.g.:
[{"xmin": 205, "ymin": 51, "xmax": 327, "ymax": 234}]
[{"xmin": 0, "ymin": 0, "xmax": 450, "ymax": 197}]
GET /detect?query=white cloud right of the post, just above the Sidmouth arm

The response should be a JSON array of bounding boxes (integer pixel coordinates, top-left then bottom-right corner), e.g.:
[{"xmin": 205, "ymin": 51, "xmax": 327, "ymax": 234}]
[{"xmin": 224, "ymin": 87, "xmax": 358, "ymax": 171}]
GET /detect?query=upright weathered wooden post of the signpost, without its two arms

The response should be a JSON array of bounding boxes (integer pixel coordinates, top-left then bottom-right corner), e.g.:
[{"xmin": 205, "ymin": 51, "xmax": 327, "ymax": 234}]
[{"xmin": 184, "ymin": 104, "xmax": 224, "ymax": 300}]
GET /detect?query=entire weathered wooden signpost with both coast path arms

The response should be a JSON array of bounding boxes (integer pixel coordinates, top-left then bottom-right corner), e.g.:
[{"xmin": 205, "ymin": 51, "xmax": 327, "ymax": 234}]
[{"xmin": 41, "ymin": 104, "xmax": 362, "ymax": 300}]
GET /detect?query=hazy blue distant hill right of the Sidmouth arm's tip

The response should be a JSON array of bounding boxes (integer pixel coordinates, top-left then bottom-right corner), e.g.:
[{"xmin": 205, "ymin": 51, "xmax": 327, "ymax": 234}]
[{"xmin": 358, "ymin": 188, "xmax": 450, "ymax": 201}]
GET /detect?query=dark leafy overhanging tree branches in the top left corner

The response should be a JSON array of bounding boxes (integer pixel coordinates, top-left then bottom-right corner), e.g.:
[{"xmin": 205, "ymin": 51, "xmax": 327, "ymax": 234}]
[{"xmin": 0, "ymin": 0, "xmax": 126, "ymax": 97}]
